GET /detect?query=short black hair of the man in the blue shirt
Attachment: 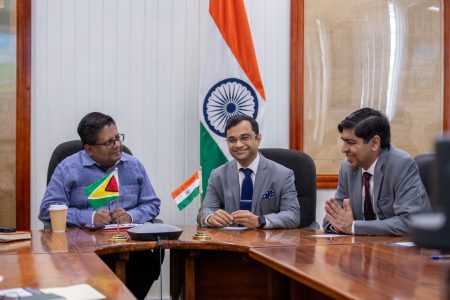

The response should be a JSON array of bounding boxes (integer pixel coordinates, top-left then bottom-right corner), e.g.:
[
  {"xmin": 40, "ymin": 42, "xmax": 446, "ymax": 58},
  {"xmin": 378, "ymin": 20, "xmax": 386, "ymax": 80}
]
[{"xmin": 77, "ymin": 112, "xmax": 116, "ymax": 146}]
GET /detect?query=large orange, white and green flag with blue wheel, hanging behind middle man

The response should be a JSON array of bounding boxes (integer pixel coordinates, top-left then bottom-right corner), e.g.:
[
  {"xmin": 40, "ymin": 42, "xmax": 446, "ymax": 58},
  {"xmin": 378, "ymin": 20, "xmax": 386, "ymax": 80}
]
[{"xmin": 200, "ymin": 0, "xmax": 266, "ymax": 195}]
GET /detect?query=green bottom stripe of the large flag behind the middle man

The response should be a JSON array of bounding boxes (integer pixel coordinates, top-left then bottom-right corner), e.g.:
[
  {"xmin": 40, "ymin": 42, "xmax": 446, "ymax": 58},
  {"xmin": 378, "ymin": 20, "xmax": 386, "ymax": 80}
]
[{"xmin": 200, "ymin": 123, "xmax": 228, "ymax": 197}]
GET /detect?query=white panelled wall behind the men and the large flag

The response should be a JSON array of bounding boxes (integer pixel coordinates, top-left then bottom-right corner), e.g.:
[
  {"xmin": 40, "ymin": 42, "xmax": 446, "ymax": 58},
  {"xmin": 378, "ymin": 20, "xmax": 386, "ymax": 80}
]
[{"xmin": 31, "ymin": 0, "xmax": 330, "ymax": 297}]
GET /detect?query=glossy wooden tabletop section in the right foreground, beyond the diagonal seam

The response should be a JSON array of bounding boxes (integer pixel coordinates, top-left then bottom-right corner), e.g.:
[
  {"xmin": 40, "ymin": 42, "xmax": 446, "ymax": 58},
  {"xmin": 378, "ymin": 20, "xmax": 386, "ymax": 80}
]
[{"xmin": 250, "ymin": 242, "xmax": 450, "ymax": 299}]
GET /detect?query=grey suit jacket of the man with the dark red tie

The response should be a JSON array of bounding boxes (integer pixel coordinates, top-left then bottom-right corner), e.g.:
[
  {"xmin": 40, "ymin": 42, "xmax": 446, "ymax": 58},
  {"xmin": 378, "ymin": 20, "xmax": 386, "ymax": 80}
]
[{"xmin": 323, "ymin": 146, "xmax": 431, "ymax": 236}]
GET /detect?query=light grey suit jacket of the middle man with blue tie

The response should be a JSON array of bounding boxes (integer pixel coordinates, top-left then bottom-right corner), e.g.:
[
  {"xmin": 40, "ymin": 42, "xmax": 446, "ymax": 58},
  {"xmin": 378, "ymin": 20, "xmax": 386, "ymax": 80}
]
[{"xmin": 197, "ymin": 155, "xmax": 300, "ymax": 228}]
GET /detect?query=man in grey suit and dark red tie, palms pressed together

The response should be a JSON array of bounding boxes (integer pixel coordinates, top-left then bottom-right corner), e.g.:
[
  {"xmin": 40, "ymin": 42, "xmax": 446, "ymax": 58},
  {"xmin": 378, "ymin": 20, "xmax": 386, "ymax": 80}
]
[{"xmin": 323, "ymin": 108, "xmax": 431, "ymax": 235}]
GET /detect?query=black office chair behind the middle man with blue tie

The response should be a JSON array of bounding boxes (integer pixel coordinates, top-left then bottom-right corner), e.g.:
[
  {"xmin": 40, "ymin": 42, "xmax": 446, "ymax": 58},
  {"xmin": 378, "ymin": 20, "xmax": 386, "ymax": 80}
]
[{"xmin": 259, "ymin": 148, "xmax": 320, "ymax": 229}]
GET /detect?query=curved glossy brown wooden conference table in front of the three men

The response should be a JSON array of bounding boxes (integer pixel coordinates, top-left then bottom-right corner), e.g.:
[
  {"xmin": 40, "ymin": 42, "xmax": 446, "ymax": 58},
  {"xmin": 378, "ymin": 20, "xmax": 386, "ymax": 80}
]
[{"xmin": 0, "ymin": 226, "xmax": 450, "ymax": 299}]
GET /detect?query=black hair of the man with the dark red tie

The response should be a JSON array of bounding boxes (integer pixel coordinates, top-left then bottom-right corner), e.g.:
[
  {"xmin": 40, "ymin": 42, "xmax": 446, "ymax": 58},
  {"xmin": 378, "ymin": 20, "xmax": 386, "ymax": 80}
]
[{"xmin": 338, "ymin": 107, "xmax": 391, "ymax": 149}]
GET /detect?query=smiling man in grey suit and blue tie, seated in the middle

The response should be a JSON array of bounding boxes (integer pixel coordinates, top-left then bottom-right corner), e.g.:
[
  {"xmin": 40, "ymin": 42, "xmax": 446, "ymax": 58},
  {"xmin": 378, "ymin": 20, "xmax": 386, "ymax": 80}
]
[{"xmin": 197, "ymin": 115, "xmax": 300, "ymax": 229}]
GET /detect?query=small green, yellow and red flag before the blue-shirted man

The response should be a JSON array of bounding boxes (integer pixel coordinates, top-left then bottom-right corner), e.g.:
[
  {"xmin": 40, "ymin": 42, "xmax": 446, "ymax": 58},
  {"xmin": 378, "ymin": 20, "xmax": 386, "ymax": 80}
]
[{"xmin": 84, "ymin": 169, "xmax": 119, "ymax": 209}]
